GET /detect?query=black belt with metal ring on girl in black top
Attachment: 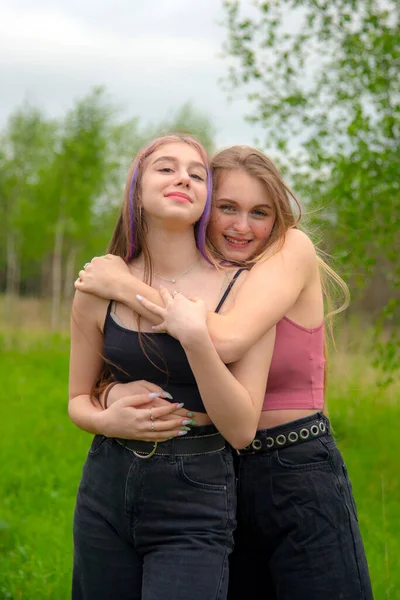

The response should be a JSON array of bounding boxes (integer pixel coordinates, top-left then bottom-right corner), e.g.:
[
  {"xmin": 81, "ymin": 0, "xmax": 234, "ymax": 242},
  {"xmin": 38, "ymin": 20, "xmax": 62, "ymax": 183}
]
[{"xmin": 114, "ymin": 433, "xmax": 226, "ymax": 458}]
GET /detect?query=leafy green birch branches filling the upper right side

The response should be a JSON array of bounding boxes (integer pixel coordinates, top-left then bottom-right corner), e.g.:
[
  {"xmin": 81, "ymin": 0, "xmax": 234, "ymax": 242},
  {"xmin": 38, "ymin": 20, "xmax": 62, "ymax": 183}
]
[{"xmin": 223, "ymin": 0, "xmax": 400, "ymax": 381}]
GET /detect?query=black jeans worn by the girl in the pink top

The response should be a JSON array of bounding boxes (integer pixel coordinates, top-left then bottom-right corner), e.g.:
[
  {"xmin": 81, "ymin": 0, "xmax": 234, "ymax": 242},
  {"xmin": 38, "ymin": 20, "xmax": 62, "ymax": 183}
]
[{"xmin": 228, "ymin": 414, "xmax": 373, "ymax": 600}]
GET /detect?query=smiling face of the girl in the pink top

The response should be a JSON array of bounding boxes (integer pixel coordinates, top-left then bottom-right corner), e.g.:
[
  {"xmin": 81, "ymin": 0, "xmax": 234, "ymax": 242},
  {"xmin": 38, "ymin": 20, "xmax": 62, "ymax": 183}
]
[{"xmin": 207, "ymin": 170, "xmax": 276, "ymax": 262}]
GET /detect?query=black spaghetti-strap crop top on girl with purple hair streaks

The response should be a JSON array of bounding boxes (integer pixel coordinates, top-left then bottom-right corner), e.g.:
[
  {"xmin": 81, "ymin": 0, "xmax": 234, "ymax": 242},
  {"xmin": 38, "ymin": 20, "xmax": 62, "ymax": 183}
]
[{"xmin": 104, "ymin": 269, "xmax": 243, "ymax": 412}]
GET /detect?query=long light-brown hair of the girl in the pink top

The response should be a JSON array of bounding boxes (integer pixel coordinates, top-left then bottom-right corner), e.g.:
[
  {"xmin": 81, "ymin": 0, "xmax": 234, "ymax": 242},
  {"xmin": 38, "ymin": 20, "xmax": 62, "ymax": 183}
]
[{"xmin": 208, "ymin": 146, "xmax": 350, "ymax": 413}]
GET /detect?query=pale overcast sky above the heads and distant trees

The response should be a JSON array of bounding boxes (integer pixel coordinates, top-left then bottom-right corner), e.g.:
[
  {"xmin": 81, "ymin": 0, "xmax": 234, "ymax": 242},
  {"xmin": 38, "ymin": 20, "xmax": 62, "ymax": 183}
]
[{"xmin": 0, "ymin": 0, "xmax": 260, "ymax": 147}]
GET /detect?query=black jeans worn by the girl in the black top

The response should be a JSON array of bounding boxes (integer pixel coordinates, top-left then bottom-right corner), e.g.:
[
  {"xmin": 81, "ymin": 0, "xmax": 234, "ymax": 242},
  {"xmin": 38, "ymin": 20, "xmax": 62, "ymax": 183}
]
[{"xmin": 72, "ymin": 426, "xmax": 236, "ymax": 600}]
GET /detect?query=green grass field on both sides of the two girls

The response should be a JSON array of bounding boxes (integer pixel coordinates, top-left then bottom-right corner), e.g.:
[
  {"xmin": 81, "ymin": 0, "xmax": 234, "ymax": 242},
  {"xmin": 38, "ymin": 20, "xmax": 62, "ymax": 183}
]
[{"xmin": 0, "ymin": 332, "xmax": 400, "ymax": 600}]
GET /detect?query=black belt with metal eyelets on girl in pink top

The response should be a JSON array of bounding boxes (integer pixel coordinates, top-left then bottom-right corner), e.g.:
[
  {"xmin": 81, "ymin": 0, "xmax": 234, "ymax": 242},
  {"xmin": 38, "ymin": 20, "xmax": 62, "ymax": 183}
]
[{"xmin": 237, "ymin": 418, "xmax": 329, "ymax": 455}]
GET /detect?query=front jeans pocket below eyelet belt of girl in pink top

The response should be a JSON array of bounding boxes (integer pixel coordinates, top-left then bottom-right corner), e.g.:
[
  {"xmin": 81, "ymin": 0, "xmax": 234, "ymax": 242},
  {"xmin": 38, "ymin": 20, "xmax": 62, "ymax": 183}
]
[{"xmin": 275, "ymin": 439, "xmax": 331, "ymax": 471}]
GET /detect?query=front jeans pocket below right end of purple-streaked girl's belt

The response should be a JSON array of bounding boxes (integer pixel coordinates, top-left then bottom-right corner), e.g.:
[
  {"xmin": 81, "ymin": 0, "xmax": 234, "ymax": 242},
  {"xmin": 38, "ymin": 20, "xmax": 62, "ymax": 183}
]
[{"xmin": 178, "ymin": 452, "xmax": 234, "ymax": 492}]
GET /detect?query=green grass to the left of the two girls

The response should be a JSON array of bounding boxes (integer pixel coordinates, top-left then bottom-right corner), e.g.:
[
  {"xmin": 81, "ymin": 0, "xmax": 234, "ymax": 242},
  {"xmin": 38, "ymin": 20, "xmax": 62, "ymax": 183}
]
[{"xmin": 0, "ymin": 336, "xmax": 89, "ymax": 600}]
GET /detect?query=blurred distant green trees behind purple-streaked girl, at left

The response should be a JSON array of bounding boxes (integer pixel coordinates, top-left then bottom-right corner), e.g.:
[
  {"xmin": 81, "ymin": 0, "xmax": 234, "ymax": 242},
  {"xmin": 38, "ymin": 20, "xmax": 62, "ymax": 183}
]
[{"xmin": 0, "ymin": 88, "xmax": 214, "ymax": 308}]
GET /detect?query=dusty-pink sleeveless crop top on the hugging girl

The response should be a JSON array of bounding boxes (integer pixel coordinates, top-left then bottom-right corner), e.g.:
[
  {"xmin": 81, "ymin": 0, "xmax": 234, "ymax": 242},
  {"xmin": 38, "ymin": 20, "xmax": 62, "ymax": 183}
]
[{"xmin": 262, "ymin": 317, "xmax": 325, "ymax": 410}]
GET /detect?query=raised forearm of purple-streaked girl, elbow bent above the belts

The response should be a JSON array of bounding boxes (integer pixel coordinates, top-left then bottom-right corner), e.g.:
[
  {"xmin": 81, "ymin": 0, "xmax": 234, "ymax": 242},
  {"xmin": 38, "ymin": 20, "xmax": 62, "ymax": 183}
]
[{"xmin": 185, "ymin": 335, "xmax": 259, "ymax": 448}]
